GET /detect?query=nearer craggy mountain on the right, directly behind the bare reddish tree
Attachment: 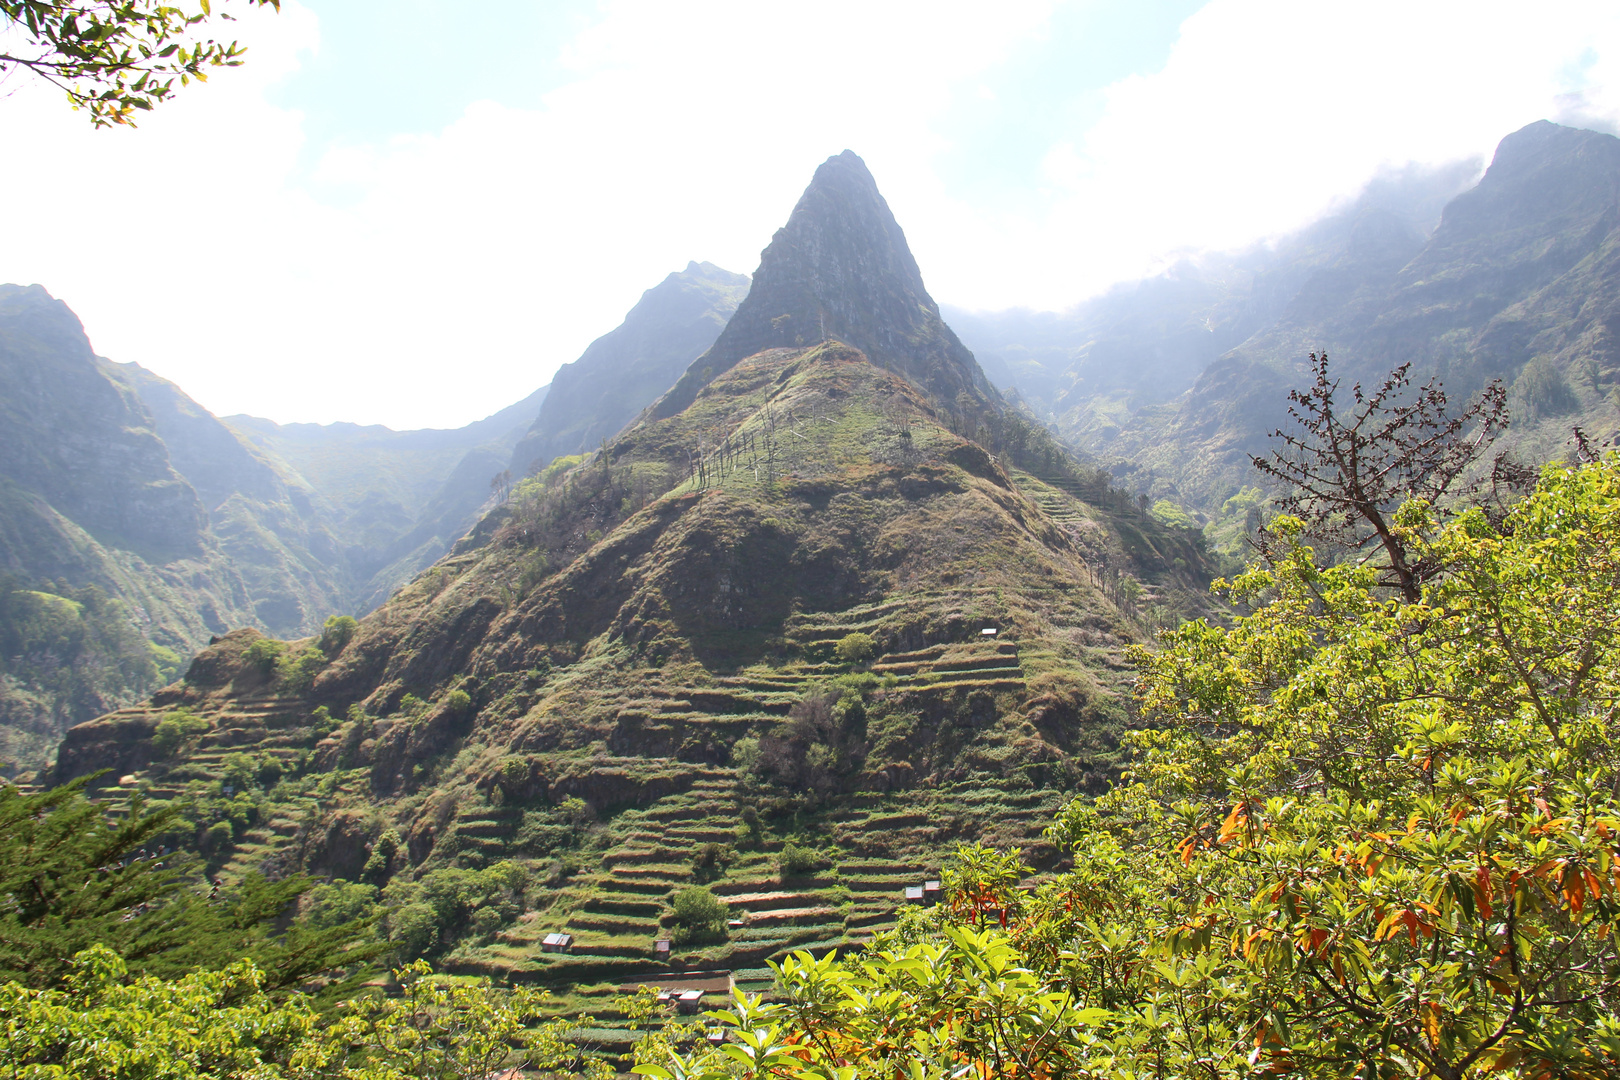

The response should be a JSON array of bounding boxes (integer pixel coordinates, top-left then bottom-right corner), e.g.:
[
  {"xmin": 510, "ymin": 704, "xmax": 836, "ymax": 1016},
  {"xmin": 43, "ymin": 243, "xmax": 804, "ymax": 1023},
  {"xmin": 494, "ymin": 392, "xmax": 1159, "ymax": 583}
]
[{"xmin": 1115, "ymin": 121, "xmax": 1620, "ymax": 507}]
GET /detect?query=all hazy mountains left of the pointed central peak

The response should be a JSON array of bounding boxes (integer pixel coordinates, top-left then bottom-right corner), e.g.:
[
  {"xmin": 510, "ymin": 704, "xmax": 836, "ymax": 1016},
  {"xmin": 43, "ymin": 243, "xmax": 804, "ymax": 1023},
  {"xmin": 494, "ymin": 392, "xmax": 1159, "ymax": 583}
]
[{"xmin": 0, "ymin": 264, "xmax": 748, "ymax": 763}]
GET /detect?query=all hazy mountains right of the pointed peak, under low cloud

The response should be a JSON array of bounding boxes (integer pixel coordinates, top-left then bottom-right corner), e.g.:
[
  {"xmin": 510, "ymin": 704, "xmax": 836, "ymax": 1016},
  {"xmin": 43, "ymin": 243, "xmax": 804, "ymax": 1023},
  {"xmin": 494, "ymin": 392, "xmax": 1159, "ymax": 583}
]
[{"xmin": 948, "ymin": 121, "xmax": 1620, "ymax": 515}]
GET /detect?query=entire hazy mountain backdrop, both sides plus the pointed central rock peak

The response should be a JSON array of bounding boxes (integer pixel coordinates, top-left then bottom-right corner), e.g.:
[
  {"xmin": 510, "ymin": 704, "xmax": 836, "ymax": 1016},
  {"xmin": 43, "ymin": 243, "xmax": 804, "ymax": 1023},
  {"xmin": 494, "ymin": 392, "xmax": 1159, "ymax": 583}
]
[{"xmin": 0, "ymin": 123, "xmax": 1620, "ymax": 777}]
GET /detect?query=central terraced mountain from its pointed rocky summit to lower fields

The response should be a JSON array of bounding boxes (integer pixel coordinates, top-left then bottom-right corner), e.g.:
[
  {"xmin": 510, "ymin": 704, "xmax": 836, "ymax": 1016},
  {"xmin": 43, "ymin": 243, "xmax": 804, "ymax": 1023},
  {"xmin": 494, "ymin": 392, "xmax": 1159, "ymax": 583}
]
[{"xmin": 57, "ymin": 155, "xmax": 1205, "ymax": 1007}]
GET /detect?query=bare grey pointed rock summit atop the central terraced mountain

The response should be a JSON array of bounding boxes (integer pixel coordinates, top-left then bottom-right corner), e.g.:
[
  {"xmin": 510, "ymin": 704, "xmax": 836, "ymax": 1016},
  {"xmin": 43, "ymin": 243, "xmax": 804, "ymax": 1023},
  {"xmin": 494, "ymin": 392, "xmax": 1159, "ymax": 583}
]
[{"xmin": 653, "ymin": 151, "xmax": 1000, "ymax": 419}]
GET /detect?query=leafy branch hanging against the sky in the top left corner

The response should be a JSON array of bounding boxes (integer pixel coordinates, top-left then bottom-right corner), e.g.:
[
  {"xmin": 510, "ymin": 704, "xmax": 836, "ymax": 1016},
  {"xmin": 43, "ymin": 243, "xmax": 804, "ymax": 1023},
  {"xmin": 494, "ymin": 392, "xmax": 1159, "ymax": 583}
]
[{"xmin": 0, "ymin": 0, "xmax": 280, "ymax": 128}]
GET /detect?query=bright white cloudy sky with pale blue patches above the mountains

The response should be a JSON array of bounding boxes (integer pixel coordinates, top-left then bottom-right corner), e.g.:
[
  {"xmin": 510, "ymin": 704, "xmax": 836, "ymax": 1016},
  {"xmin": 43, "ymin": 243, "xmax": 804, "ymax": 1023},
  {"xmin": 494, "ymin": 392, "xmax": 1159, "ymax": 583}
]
[{"xmin": 0, "ymin": 0, "xmax": 1620, "ymax": 427}]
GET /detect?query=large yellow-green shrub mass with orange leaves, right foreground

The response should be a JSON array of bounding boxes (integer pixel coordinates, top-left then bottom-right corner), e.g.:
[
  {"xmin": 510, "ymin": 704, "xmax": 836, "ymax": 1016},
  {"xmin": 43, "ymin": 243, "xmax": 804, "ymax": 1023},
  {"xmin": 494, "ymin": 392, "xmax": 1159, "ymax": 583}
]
[{"xmin": 637, "ymin": 424, "xmax": 1620, "ymax": 1080}]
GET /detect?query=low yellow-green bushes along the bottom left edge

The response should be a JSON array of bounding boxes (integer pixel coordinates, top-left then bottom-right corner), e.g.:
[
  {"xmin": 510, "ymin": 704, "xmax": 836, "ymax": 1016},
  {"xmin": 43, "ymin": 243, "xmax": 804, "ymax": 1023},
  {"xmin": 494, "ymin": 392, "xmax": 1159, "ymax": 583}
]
[{"xmin": 0, "ymin": 946, "xmax": 612, "ymax": 1080}]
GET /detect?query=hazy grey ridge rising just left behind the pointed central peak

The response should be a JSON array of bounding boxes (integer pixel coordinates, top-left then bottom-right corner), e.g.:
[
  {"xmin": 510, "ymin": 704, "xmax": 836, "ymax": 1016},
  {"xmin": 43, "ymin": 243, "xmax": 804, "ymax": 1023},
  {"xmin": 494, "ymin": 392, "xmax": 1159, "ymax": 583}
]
[{"xmin": 512, "ymin": 262, "xmax": 748, "ymax": 476}]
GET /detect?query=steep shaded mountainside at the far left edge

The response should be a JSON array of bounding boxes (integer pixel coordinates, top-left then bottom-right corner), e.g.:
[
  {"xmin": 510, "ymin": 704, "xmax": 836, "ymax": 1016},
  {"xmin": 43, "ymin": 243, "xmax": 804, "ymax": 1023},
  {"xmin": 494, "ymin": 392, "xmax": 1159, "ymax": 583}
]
[{"xmin": 0, "ymin": 285, "xmax": 268, "ymax": 767}]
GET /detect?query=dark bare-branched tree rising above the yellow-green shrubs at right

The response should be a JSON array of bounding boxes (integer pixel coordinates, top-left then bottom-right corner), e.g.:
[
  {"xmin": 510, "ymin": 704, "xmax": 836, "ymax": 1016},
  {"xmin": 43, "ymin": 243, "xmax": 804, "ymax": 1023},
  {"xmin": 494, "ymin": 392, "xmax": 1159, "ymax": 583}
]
[{"xmin": 1251, "ymin": 351, "xmax": 1508, "ymax": 602}]
